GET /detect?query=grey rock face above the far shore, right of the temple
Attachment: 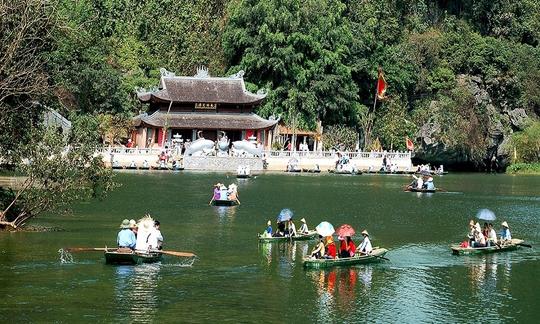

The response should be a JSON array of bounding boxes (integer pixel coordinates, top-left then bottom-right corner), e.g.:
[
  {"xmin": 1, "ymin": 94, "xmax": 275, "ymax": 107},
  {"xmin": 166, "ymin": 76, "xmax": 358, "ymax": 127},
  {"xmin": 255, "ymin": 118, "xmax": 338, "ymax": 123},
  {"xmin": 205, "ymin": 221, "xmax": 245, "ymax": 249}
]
[{"xmin": 415, "ymin": 75, "xmax": 529, "ymax": 170}]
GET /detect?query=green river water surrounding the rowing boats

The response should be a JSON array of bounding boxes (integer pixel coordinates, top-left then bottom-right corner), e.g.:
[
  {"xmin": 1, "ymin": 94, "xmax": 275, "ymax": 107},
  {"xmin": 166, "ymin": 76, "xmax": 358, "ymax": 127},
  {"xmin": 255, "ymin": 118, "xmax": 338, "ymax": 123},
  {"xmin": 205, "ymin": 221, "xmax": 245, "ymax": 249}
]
[{"xmin": 0, "ymin": 173, "xmax": 540, "ymax": 323}]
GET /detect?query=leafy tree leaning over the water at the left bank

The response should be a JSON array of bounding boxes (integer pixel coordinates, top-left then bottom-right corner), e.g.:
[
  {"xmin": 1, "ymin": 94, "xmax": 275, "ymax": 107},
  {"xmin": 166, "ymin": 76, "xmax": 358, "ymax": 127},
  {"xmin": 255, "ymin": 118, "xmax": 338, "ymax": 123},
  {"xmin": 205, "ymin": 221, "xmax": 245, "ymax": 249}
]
[{"xmin": 0, "ymin": 127, "xmax": 115, "ymax": 229}]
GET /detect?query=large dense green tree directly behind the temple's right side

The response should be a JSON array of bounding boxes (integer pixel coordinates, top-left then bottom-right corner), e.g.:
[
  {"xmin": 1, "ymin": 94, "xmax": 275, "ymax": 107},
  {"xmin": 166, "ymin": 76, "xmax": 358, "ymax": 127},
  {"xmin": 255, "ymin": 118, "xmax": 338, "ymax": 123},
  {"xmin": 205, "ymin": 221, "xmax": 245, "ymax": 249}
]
[{"xmin": 223, "ymin": 0, "xmax": 358, "ymax": 129}]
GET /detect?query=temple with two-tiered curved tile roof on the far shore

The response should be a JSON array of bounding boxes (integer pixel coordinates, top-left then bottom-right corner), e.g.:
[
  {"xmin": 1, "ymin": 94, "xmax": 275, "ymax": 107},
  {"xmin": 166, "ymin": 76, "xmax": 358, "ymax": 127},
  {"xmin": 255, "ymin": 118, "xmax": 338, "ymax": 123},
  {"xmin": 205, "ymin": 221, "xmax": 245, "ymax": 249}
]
[{"xmin": 131, "ymin": 67, "xmax": 278, "ymax": 149}]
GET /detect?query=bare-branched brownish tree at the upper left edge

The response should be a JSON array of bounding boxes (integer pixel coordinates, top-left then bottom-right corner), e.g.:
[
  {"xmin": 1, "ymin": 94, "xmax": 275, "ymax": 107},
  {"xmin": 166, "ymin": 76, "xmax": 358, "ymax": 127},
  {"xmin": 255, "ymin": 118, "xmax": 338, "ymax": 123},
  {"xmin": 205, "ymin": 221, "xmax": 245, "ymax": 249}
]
[{"xmin": 0, "ymin": 0, "xmax": 56, "ymax": 162}]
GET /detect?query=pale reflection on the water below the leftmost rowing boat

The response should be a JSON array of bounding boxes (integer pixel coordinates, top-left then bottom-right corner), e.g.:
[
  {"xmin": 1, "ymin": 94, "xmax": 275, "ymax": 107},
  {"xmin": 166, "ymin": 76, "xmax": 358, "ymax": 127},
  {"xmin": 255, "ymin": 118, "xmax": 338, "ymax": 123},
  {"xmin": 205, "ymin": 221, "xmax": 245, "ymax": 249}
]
[{"xmin": 115, "ymin": 263, "xmax": 161, "ymax": 323}]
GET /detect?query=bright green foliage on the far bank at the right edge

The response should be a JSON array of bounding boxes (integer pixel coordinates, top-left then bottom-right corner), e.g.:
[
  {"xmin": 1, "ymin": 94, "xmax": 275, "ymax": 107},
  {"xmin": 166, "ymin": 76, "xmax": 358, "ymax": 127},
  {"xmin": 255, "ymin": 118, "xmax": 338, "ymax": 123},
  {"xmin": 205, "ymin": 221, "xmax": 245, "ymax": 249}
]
[{"xmin": 512, "ymin": 121, "xmax": 540, "ymax": 163}]
